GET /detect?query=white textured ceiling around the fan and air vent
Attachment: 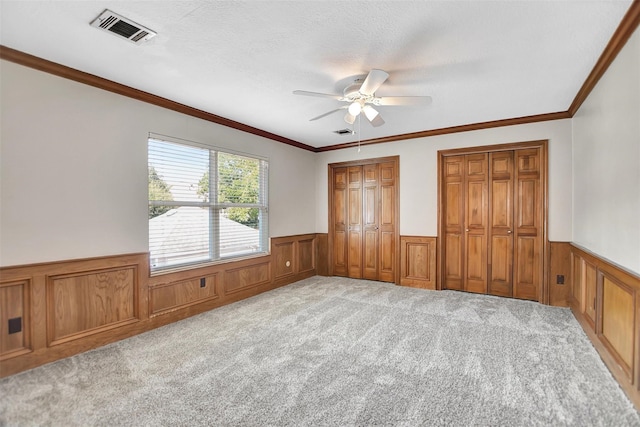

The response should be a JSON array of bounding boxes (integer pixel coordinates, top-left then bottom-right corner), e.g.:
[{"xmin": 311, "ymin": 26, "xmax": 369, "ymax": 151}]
[{"xmin": 0, "ymin": 0, "xmax": 631, "ymax": 147}]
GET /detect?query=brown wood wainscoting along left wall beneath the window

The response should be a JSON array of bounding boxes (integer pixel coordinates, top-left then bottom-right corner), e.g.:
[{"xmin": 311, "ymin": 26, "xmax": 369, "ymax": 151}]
[{"xmin": 0, "ymin": 234, "xmax": 326, "ymax": 377}]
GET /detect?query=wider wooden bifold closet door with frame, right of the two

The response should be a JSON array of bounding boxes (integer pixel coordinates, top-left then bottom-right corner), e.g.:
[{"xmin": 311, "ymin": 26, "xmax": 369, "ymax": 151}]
[{"xmin": 440, "ymin": 144, "xmax": 546, "ymax": 301}]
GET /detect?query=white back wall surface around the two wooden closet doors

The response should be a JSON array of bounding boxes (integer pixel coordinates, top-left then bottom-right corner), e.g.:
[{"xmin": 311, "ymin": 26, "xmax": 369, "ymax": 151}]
[{"xmin": 316, "ymin": 119, "xmax": 571, "ymax": 241}]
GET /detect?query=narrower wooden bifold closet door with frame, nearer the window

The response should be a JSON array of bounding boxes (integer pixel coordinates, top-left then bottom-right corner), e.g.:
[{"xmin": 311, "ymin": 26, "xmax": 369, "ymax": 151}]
[{"xmin": 329, "ymin": 157, "xmax": 399, "ymax": 282}]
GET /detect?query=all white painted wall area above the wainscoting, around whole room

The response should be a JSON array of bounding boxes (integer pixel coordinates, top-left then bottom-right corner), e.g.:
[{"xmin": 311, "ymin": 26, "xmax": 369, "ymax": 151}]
[{"xmin": 5, "ymin": 26, "xmax": 640, "ymax": 272}]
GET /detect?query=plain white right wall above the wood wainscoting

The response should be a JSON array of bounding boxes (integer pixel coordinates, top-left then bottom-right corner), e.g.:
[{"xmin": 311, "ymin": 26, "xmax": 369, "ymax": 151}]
[{"xmin": 572, "ymin": 26, "xmax": 640, "ymax": 274}]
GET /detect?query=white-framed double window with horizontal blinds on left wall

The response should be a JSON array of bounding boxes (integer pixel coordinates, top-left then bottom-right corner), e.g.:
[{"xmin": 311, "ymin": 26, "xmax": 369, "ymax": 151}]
[{"xmin": 148, "ymin": 138, "xmax": 269, "ymax": 270}]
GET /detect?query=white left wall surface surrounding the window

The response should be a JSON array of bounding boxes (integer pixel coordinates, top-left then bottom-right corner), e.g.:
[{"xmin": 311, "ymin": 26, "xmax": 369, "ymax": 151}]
[{"xmin": 0, "ymin": 61, "xmax": 316, "ymax": 266}]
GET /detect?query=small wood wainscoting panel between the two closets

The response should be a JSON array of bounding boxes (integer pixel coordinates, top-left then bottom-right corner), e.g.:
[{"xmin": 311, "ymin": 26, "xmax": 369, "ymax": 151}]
[{"xmin": 400, "ymin": 236, "xmax": 437, "ymax": 290}]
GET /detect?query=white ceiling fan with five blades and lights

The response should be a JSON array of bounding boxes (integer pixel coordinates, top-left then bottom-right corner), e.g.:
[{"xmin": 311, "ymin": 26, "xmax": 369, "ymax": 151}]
[{"xmin": 293, "ymin": 69, "xmax": 431, "ymax": 127}]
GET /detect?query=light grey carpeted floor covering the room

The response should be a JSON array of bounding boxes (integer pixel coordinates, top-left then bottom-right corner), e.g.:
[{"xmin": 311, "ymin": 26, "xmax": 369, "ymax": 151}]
[{"xmin": 0, "ymin": 277, "xmax": 640, "ymax": 426}]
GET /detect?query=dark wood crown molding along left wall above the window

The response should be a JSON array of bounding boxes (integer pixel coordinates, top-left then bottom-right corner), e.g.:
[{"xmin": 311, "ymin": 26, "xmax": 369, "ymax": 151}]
[{"xmin": 0, "ymin": 45, "xmax": 316, "ymax": 152}]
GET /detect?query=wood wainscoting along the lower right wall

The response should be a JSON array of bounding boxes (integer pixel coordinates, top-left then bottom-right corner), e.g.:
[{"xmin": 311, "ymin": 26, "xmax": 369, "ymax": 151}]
[{"xmin": 568, "ymin": 245, "xmax": 640, "ymax": 408}]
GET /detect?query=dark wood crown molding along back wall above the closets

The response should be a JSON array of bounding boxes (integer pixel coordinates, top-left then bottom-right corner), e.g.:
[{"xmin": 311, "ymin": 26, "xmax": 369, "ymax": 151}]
[{"xmin": 316, "ymin": 111, "xmax": 571, "ymax": 153}]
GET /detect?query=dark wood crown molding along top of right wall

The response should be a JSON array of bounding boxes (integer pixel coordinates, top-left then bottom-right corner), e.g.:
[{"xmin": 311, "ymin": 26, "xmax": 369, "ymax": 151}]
[{"xmin": 567, "ymin": 0, "xmax": 640, "ymax": 117}]
